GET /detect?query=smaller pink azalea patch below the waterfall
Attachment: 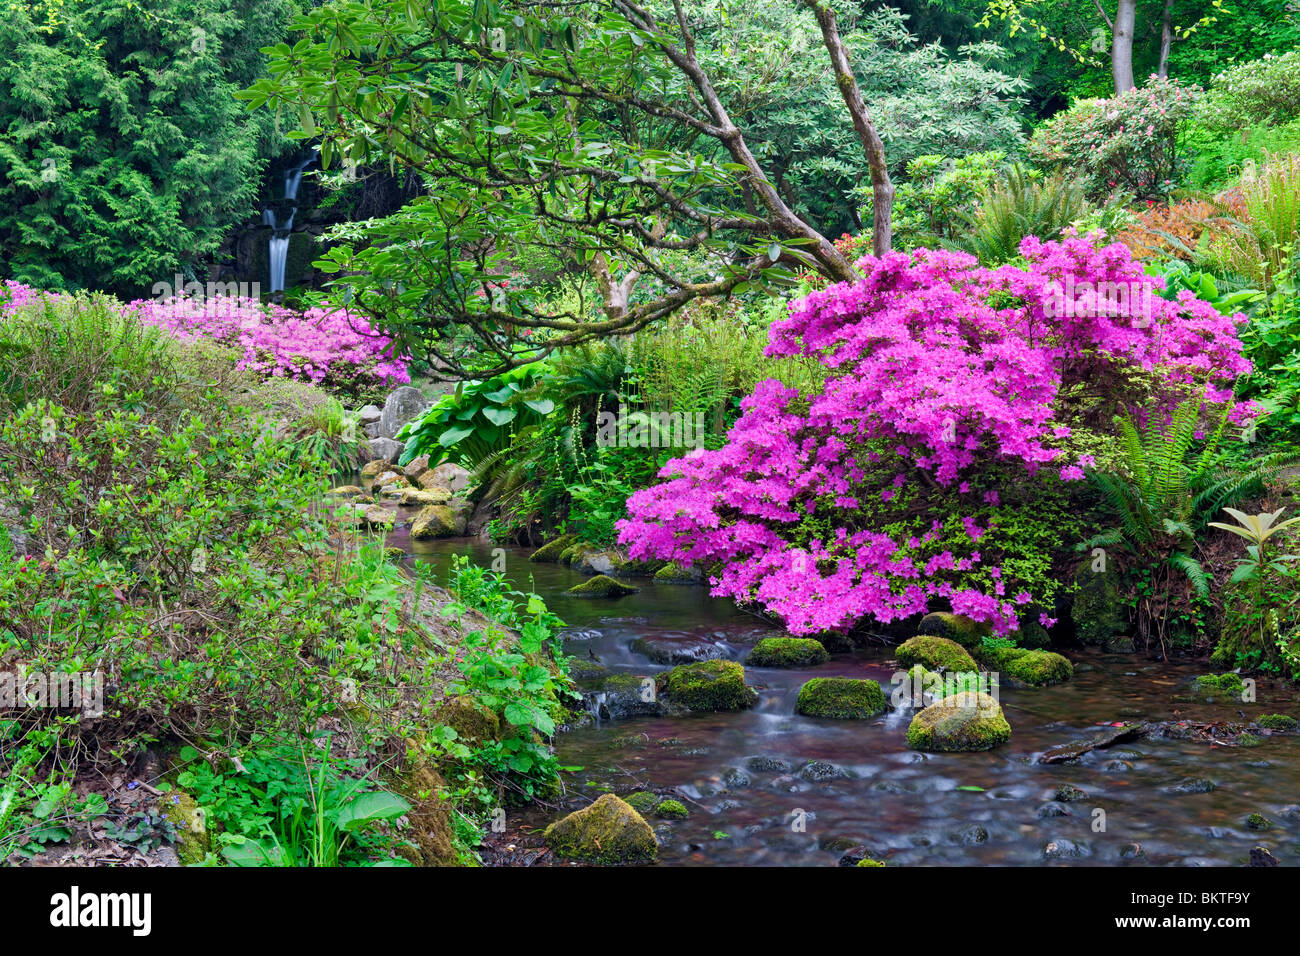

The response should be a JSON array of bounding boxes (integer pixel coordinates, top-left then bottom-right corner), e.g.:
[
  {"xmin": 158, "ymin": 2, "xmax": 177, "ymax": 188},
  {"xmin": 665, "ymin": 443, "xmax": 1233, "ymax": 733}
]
[{"xmin": 127, "ymin": 295, "xmax": 411, "ymax": 394}]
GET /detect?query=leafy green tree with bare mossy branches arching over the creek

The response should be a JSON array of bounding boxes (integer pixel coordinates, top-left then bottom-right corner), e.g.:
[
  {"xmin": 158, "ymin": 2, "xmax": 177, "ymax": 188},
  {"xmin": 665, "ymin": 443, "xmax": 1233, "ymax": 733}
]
[{"xmin": 243, "ymin": 0, "xmax": 915, "ymax": 375}]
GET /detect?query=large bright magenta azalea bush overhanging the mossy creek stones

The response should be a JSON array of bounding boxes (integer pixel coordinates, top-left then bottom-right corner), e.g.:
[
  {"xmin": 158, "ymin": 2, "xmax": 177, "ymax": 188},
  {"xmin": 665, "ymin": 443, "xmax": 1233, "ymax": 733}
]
[{"xmin": 619, "ymin": 235, "xmax": 1249, "ymax": 633}]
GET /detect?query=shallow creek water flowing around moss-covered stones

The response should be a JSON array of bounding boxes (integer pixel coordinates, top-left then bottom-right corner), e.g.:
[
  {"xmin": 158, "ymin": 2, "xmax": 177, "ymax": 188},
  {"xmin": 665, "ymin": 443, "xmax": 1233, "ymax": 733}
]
[{"xmin": 389, "ymin": 531, "xmax": 1300, "ymax": 866}]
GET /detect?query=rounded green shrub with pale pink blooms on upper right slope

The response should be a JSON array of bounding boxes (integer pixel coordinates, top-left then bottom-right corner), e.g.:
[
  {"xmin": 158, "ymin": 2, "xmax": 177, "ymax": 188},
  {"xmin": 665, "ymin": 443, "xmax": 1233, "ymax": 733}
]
[{"xmin": 1028, "ymin": 77, "xmax": 1201, "ymax": 199}]
